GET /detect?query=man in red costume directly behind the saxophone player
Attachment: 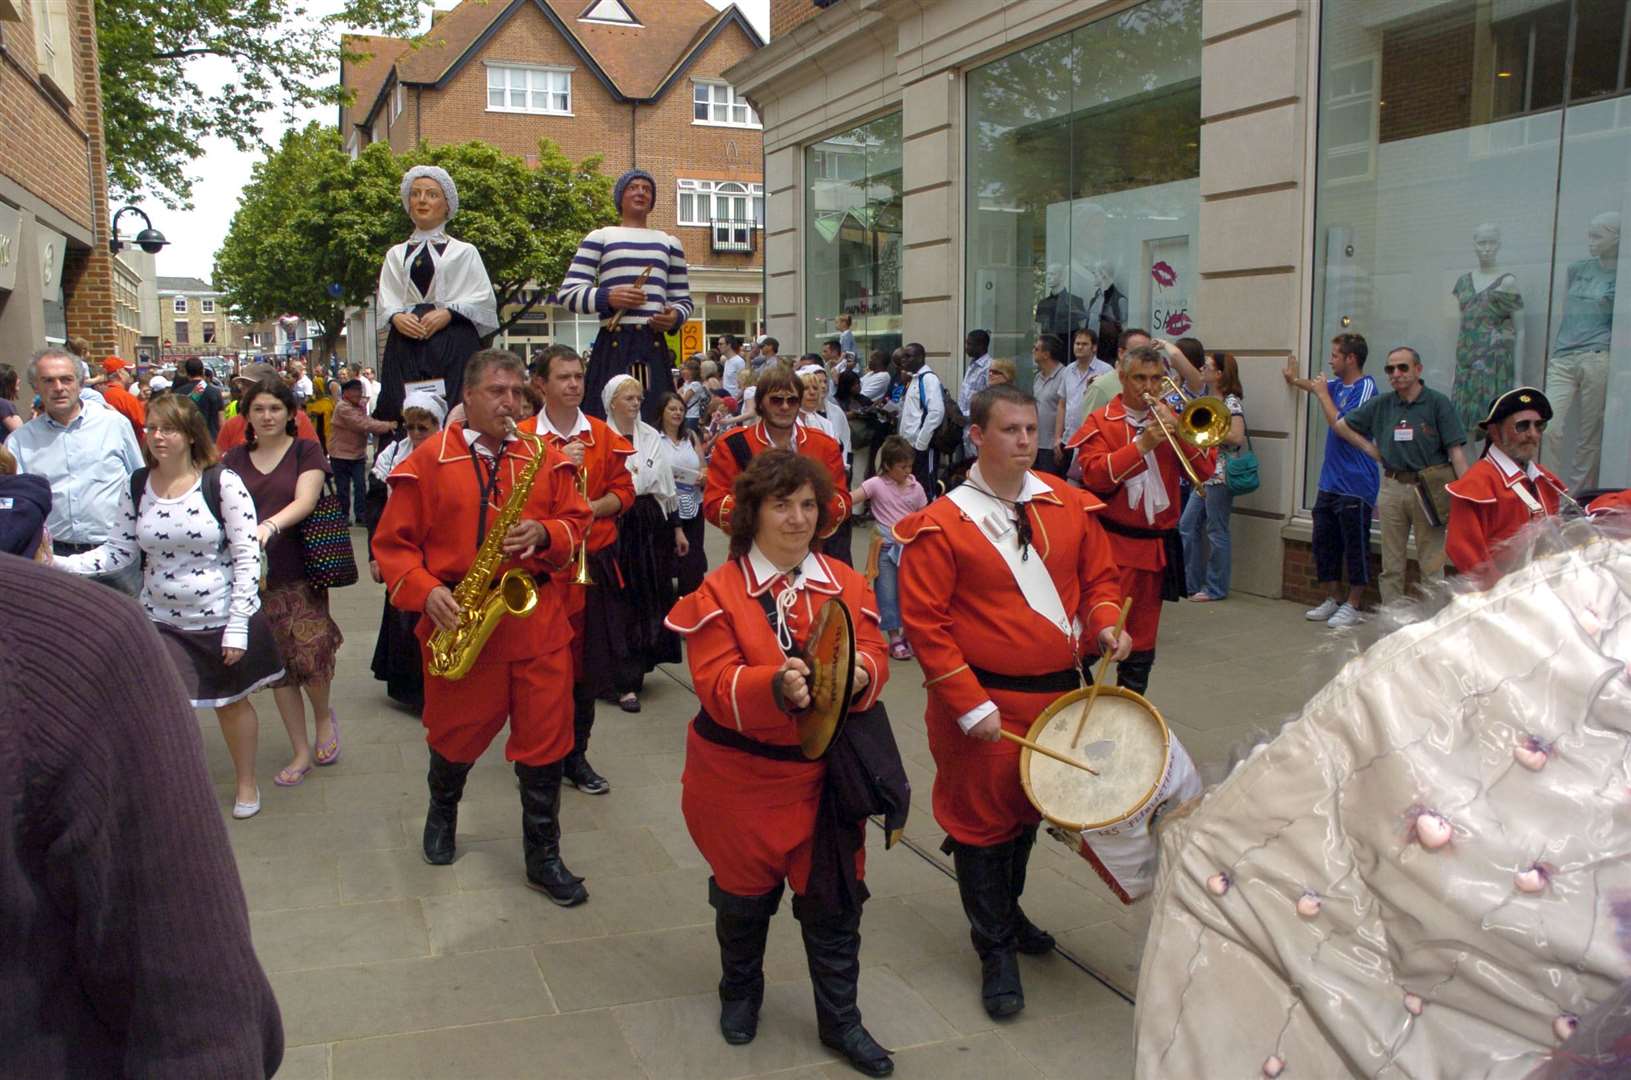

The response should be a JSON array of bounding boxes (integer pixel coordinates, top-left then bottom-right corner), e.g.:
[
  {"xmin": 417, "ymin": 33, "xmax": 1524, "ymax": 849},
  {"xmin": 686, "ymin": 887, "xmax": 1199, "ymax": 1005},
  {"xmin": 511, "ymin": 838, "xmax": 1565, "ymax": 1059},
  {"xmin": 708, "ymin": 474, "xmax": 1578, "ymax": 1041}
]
[{"xmin": 520, "ymin": 344, "xmax": 634, "ymax": 795}]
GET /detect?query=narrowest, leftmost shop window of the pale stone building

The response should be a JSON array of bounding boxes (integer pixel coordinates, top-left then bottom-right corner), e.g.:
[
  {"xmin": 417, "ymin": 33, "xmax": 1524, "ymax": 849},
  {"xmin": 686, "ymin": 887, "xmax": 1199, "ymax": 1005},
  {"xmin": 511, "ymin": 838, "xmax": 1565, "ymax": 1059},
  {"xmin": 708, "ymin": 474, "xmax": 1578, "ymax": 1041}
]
[{"xmin": 802, "ymin": 113, "xmax": 900, "ymax": 357}]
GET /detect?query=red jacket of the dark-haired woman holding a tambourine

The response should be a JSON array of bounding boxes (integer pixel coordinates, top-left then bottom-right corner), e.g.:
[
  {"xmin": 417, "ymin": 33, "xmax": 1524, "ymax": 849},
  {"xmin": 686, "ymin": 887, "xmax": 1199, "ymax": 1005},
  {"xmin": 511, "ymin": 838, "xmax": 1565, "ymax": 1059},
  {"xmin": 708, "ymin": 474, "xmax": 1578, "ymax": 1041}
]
[{"xmin": 667, "ymin": 555, "xmax": 889, "ymax": 809}]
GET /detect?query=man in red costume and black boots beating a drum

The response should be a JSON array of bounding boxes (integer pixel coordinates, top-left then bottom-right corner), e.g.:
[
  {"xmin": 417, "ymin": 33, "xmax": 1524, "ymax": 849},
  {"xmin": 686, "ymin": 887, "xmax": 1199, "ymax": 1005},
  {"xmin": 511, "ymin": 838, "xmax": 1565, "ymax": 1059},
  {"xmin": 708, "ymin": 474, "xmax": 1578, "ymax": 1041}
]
[{"xmin": 895, "ymin": 385, "xmax": 1135, "ymax": 1018}]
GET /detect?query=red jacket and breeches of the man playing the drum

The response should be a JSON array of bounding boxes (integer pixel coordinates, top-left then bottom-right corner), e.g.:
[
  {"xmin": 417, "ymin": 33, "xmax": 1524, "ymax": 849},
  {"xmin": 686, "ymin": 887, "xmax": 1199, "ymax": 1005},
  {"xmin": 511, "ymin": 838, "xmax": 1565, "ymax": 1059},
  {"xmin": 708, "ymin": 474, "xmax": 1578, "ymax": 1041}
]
[{"xmin": 895, "ymin": 473, "xmax": 1120, "ymax": 847}]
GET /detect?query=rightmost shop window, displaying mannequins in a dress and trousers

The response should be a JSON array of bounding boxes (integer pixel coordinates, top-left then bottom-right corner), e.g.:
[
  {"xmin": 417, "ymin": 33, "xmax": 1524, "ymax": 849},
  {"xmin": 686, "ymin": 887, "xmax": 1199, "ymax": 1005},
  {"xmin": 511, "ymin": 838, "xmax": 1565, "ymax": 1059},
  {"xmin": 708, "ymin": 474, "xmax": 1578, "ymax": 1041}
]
[{"xmin": 1305, "ymin": 0, "xmax": 1631, "ymax": 504}]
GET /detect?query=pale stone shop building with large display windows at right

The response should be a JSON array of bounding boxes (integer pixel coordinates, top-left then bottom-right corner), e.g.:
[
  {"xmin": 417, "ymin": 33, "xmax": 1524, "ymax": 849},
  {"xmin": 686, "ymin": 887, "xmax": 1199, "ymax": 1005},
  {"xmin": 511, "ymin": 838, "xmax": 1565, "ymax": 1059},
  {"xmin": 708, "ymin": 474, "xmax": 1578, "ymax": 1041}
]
[{"xmin": 740, "ymin": 0, "xmax": 1631, "ymax": 597}]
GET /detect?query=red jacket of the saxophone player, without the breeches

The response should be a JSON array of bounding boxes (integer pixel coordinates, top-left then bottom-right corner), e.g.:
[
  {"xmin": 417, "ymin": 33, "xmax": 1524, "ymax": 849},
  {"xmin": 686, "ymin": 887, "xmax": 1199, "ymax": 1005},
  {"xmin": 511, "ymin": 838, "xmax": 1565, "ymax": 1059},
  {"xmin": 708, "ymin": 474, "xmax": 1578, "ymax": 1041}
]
[{"xmin": 373, "ymin": 424, "xmax": 589, "ymax": 661}]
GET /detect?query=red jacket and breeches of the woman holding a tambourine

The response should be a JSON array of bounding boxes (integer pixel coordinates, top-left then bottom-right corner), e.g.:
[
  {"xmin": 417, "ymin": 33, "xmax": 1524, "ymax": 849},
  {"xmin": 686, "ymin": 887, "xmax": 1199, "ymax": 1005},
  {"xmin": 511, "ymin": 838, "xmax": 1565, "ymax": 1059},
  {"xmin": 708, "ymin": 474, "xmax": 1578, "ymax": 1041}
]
[{"xmin": 667, "ymin": 555, "xmax": 889, "ymax": 896}]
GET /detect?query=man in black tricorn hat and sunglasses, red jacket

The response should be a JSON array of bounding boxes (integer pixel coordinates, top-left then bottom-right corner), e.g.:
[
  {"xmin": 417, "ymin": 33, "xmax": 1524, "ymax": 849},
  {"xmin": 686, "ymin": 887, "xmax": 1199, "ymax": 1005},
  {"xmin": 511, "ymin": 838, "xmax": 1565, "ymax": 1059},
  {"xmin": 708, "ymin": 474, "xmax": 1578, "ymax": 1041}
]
[{"xmin": 1443, "ymin": 387, "xmax": 1566, "ymax": 587}]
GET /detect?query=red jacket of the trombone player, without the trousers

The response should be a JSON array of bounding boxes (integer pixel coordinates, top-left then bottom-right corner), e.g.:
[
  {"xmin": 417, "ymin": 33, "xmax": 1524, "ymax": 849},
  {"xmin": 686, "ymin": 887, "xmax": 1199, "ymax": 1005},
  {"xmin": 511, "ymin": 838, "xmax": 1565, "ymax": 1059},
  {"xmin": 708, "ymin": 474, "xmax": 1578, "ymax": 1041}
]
[{"xmin": 1065, "ymin": 396, "xmax": 1217, "ymax": 569}]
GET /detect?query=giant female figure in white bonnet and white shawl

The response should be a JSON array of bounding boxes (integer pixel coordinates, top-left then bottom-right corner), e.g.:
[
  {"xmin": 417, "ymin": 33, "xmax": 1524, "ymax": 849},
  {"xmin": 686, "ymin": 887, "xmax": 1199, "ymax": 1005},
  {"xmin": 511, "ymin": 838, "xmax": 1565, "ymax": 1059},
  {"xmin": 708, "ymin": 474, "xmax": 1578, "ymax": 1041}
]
[{"xmin": 373, "ymin": 165, "xmax": 499, "ymax": 421}]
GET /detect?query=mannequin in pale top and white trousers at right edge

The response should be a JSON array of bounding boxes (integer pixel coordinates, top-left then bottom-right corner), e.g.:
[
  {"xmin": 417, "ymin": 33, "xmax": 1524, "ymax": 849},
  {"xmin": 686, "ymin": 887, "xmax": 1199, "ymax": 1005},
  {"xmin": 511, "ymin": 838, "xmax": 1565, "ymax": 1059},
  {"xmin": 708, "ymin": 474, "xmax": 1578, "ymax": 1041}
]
[{"xmin": 1545, "ymin": 210, "xmax": 1620, "ymax": 491}]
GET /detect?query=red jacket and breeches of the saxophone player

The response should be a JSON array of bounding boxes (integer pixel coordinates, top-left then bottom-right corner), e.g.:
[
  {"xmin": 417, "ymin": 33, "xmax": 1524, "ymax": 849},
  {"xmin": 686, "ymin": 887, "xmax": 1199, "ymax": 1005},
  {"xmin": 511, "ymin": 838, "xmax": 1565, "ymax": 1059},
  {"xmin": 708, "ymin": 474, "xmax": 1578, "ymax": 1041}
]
[{"xmin": 373, "ymin": 424, "xmax": 589, "ymax": 765}]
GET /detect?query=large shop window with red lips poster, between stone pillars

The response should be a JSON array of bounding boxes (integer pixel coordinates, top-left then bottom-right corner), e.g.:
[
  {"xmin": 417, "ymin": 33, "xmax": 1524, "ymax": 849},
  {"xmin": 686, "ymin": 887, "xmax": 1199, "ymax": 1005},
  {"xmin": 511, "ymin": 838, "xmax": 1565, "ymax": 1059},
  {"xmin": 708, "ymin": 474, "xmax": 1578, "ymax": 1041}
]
[{"xmin": 966, "ymin": 0, "xmax": 1205, "ymax": 385}]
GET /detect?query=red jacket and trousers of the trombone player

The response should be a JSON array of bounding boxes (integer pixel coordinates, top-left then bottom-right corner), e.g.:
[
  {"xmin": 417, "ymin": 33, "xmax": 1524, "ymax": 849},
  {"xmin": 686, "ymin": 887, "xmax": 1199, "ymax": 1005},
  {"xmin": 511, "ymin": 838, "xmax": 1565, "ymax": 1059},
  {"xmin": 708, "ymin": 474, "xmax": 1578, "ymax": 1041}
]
[{"xmin": 1065, "ymin": 396, "xmax": 1215, "ymax": 651}]
